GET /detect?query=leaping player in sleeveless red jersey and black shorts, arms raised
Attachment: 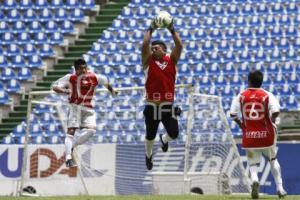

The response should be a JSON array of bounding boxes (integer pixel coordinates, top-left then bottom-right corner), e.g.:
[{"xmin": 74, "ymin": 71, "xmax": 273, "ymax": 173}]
[{"xmin": 142, "ymin": 14, "xmax": 183, "ymax": 170}]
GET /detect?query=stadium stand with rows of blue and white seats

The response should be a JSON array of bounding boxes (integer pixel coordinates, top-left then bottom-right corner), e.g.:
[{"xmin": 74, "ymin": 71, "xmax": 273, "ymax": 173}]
[{"xmin": 0, "ymin": 0, "xmax": 300, "ymax": 143}]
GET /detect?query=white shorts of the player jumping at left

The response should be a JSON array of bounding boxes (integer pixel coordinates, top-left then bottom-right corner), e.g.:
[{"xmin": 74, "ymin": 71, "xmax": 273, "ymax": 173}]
[{"xmin": 67, "ymin": 104, "xmax": 96, "ymax": 128}]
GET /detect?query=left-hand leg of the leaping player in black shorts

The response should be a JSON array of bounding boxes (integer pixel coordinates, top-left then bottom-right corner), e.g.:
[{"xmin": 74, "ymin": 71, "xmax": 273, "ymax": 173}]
[{"xmin": 143, "ymin": 104, "xmax": 160, "ymax": 170}]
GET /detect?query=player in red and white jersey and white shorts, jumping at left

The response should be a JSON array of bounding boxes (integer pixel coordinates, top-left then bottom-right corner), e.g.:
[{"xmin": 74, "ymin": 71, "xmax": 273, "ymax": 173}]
[{"xmin": 52, "ymin": 59, "xmax": 117, "ymax": 167}]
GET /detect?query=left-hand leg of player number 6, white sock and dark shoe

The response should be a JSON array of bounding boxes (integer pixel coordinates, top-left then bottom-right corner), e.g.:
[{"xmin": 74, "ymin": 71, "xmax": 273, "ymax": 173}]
[{"xmin": 246, "ymin": 150, "xmax": 261, "ymax": 199}]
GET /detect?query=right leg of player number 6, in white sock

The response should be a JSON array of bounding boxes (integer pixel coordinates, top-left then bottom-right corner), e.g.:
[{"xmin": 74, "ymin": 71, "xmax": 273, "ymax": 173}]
[{"xmin": 263, "ymin": 145, "xmax": 287, "ymax": 198}]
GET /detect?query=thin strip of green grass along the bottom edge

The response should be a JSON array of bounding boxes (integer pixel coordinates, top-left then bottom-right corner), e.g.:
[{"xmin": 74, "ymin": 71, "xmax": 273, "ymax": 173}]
[{"xmin": 0, "ymin": 195, "xmax": 300, "ymax": 200}]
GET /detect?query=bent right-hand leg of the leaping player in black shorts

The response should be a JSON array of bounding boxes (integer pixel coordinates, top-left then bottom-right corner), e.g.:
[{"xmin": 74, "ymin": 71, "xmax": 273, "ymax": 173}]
[{"xmin": 159, "ymin": 105, "xmax": 179, "ymax": 152}]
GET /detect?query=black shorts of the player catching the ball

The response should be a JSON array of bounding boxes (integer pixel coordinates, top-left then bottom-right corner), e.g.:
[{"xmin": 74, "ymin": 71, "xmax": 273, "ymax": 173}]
[{"xmin": 144, "ymin": 104, "xmax": 179, "ymax": 140}]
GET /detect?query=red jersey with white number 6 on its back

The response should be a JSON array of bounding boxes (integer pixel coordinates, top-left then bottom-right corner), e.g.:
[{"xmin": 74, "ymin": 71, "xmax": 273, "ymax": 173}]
[{"xmin": 239, "ymin": 88, "xmax": 279, "ymax": 148}]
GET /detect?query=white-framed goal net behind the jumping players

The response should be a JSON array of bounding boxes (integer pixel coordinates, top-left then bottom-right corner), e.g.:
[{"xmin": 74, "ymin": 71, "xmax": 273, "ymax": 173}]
[{"xmin": 18, "ymin": 85, "xmax": 249, "ymax": 195}]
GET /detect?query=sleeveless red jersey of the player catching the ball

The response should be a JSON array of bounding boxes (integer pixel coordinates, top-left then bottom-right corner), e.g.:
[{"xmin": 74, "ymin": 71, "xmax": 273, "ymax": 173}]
[{"xmin": 145, "ymin": 55, "xmax": 176, "ymax": 102}]
